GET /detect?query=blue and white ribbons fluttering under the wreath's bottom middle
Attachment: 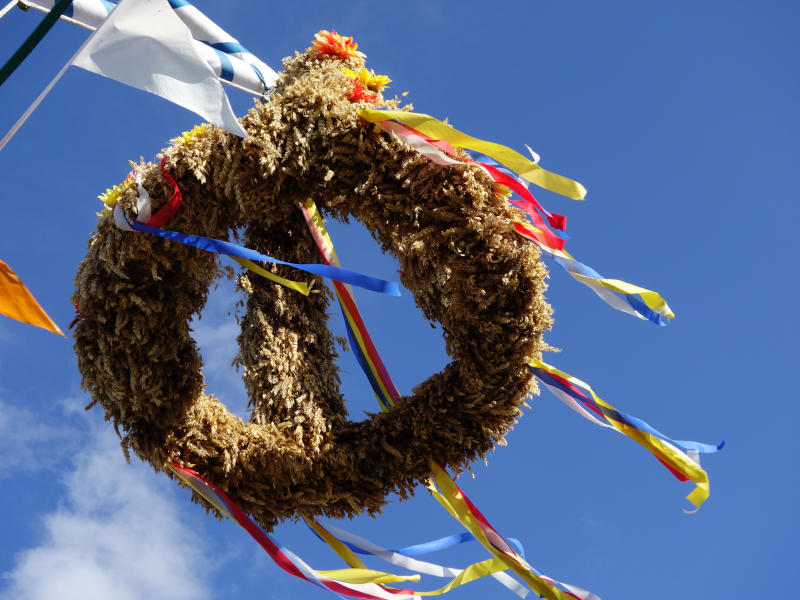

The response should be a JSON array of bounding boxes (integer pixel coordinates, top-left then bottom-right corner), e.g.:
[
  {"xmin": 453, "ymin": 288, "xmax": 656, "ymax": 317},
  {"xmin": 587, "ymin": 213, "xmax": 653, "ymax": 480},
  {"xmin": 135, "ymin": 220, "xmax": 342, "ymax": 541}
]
[{"xmin": 309, "ymin": 520, "xmax": 529, "ymax": 598}]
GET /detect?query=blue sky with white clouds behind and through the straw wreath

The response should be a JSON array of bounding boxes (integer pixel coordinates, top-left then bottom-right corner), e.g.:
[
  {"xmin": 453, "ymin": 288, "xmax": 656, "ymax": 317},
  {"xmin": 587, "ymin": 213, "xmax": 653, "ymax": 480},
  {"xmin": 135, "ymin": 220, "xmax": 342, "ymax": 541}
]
[{"xmin": 0, "ymin": 0, "xmax": 800, "ymax": 600}]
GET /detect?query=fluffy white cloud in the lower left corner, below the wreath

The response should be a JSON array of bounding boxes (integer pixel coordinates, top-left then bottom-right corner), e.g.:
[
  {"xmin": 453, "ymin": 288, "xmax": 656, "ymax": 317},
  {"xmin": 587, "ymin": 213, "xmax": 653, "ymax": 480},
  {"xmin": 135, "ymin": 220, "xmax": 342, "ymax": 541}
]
[{"xmin": 0, "ymin": 424, "xmax": 216, "ymax": 600}]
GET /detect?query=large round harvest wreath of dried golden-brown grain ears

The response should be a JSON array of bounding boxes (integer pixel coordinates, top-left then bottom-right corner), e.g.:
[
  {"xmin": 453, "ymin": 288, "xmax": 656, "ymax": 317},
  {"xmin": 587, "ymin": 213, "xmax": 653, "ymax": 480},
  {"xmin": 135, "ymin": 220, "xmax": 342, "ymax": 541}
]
[{"xmin": 73, "ymin": 51, "xmax": 551, "ymax": 530}]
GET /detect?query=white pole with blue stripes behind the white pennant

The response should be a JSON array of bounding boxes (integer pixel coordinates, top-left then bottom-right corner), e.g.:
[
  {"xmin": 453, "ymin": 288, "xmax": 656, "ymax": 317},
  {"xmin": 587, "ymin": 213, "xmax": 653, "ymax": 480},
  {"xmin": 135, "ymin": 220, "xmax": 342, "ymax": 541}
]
[{"xmin": 24, "ymin": 0, "xmax": 278, "ymax": 95}]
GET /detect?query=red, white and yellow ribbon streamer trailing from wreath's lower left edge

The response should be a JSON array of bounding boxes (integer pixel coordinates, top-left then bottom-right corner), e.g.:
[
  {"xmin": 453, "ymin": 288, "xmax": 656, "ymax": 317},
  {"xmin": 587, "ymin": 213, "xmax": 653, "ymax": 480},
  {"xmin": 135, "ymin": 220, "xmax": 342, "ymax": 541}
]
[{"xmin": 166, "ymin": 462, "xmax": 419, "ymax": 600}]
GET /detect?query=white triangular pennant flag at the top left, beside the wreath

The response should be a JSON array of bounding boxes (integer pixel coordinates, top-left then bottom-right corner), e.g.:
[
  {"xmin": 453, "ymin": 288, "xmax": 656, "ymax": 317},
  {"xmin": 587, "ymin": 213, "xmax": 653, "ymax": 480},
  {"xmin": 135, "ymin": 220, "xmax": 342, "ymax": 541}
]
[{"xmin": 72, "ymin": 0, "xmax": 248, "ymax": 137}]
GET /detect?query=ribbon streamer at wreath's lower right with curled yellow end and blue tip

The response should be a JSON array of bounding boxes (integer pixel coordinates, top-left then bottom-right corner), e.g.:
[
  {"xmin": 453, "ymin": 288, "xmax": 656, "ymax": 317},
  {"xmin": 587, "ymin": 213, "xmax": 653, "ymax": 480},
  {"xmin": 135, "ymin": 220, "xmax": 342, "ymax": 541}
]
[{"xmin": 528, "ymin": 359, "xmax": 725, "ymax": 512}]
